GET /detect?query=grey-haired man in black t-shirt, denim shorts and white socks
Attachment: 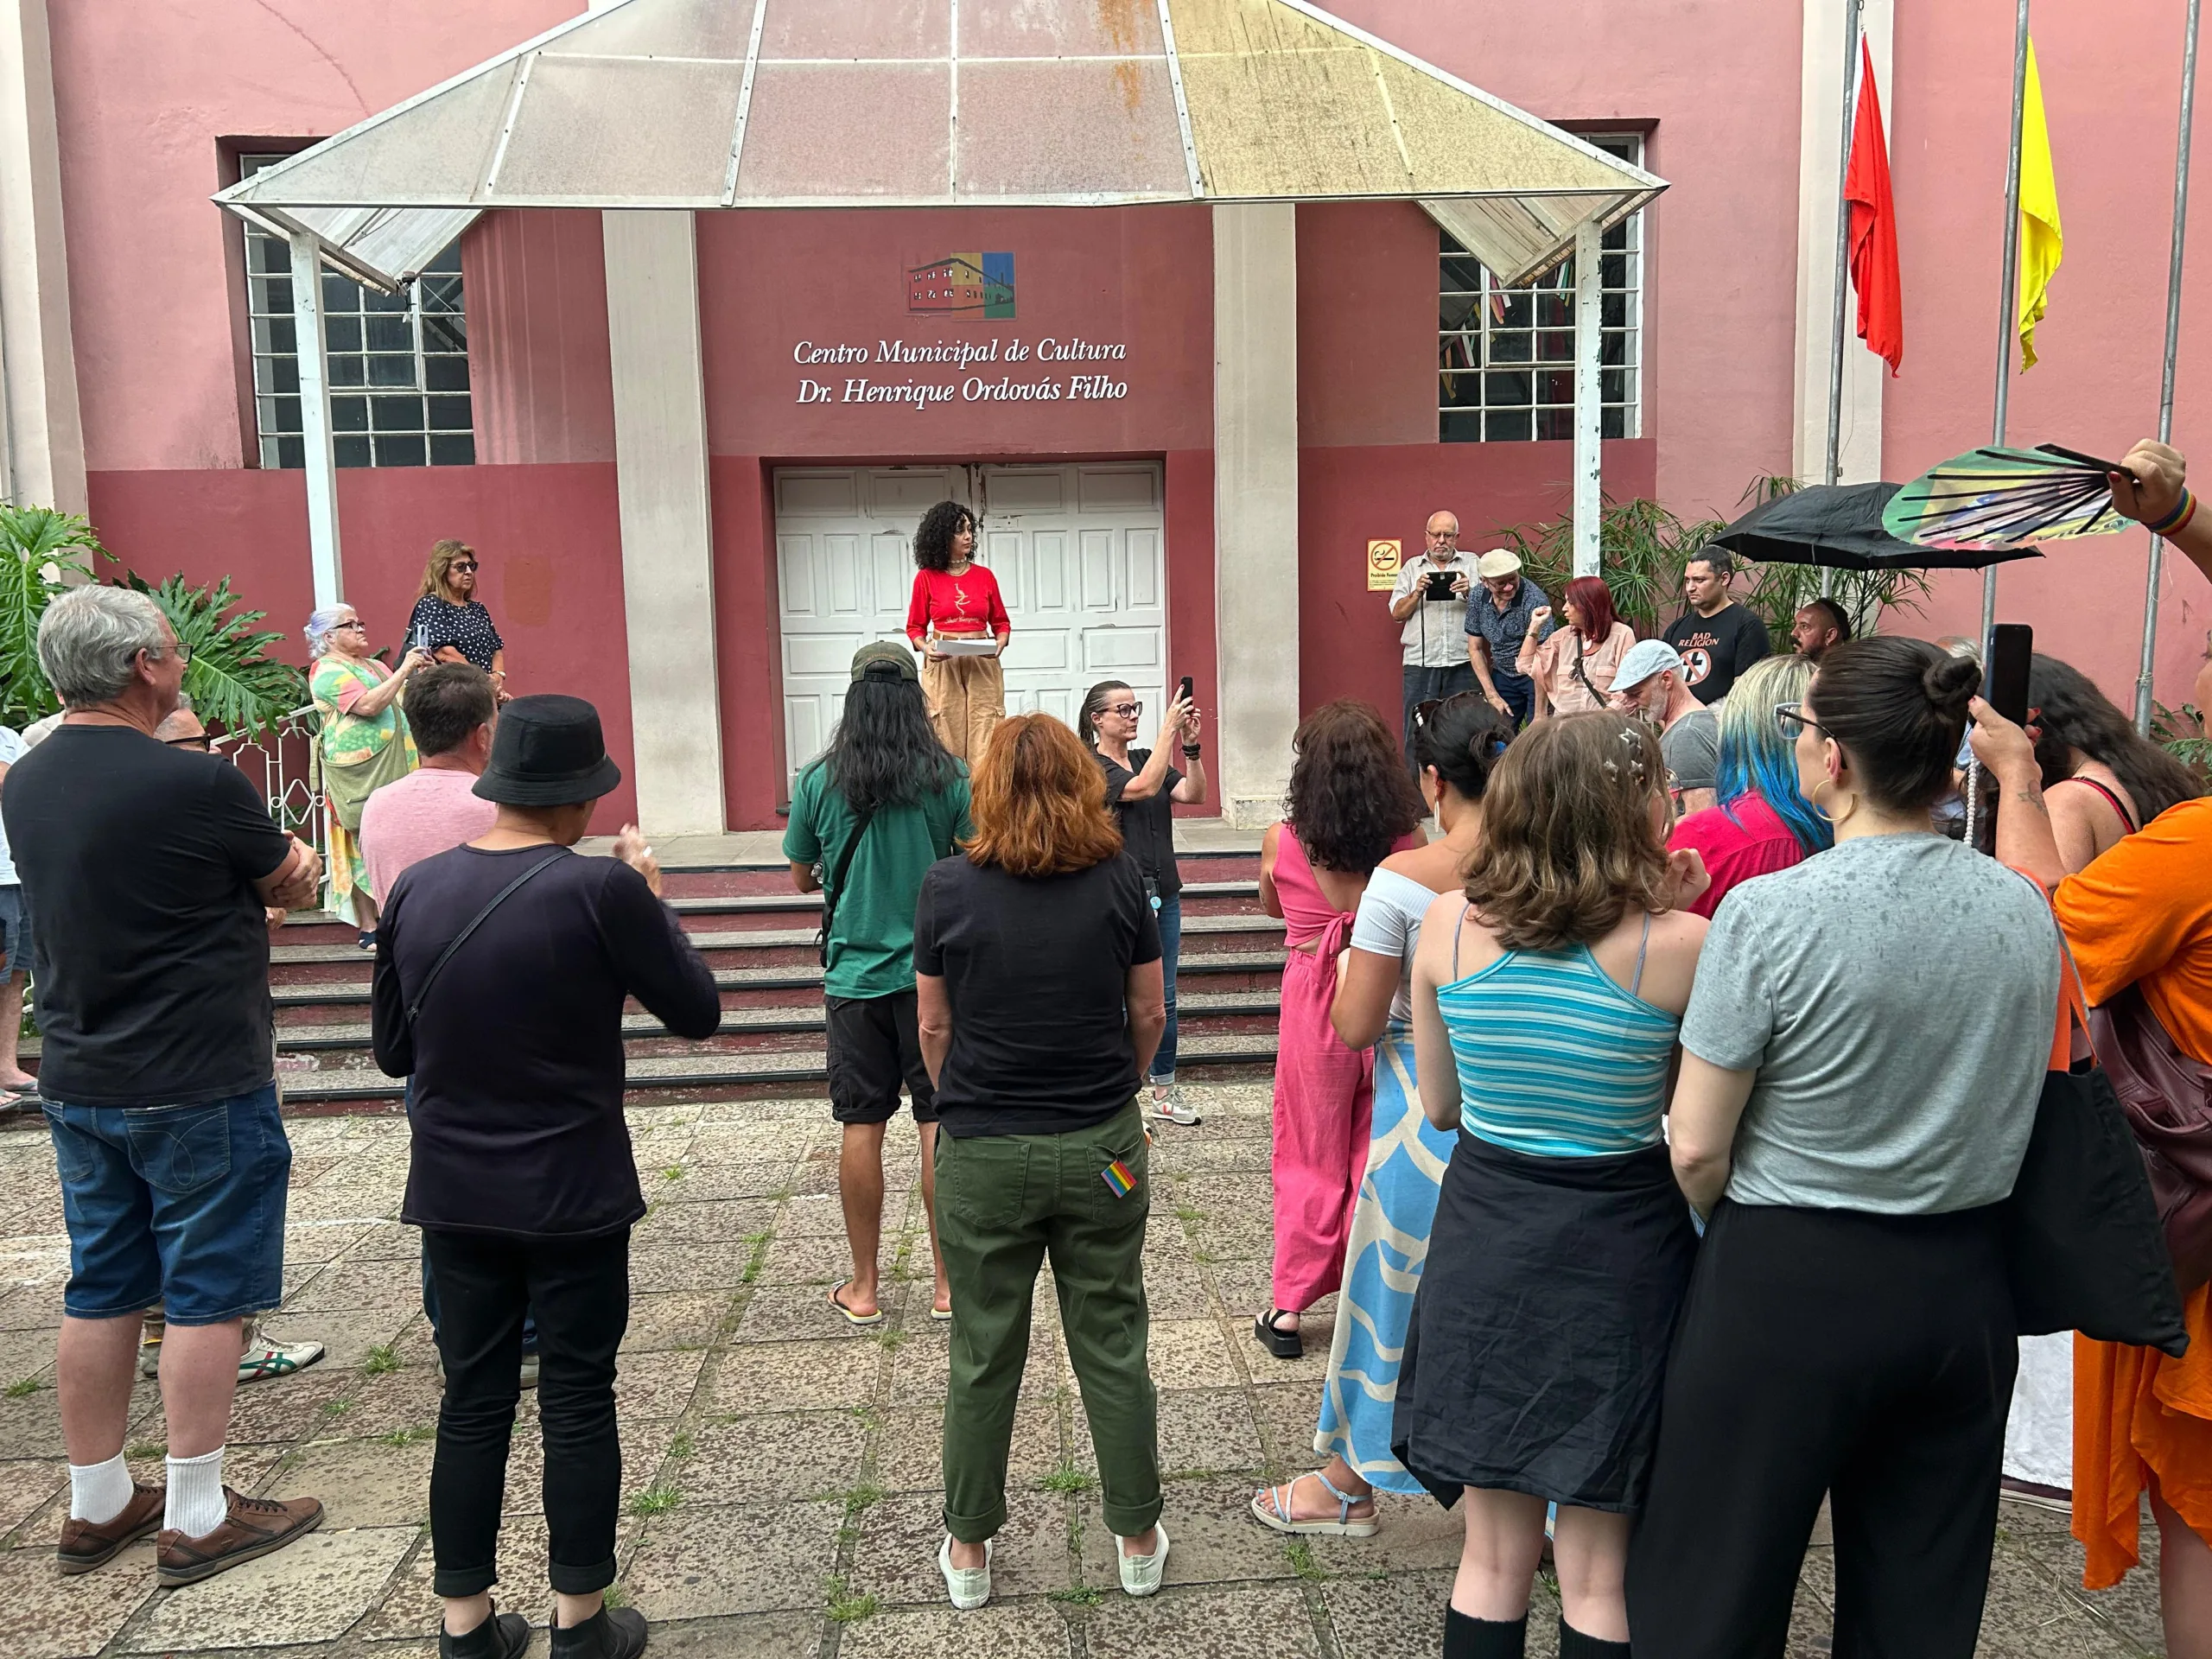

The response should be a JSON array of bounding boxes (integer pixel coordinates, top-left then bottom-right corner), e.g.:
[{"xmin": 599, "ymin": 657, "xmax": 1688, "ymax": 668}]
[{"xmin": 0, "ymin": 586, "xmax": 323, "ymax": 1586}]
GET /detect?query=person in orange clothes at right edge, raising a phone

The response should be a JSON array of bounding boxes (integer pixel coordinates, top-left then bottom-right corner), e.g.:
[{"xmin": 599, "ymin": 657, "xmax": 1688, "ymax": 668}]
[{"xmin": 1974, "ymin": 702, "xmax": 2212, "ymax": 1659}]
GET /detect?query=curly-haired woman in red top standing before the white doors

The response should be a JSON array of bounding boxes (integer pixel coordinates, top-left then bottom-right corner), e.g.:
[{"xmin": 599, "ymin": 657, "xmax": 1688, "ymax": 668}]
[{"xmin": 907, "ymin": 502, "xmax": 1013, "ymax": 763}]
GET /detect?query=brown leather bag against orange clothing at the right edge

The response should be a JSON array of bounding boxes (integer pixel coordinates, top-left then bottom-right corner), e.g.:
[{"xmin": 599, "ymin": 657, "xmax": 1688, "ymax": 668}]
[{"xmin": 2088, "ymin": 984, "xmax": 2212, "ymax": 1296}]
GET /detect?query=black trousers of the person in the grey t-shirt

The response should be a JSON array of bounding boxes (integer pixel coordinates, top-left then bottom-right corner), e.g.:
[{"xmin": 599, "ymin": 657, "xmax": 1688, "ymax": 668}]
[{"xmin": 1628, "ymin": 1201, "xmax": 2019, "ymax": 1659}]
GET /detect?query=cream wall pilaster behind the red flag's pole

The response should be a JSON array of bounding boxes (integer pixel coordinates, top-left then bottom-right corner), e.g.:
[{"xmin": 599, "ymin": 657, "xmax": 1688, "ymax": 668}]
[{"xmin": 1789, "ymin": 0, "xmax": 1893, "ymax": 485}]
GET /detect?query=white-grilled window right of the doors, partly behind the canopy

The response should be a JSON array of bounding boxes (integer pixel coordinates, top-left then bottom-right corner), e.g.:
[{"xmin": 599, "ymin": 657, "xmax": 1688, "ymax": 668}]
[{"xmin": 1438, "ymin": 135, "xmax": 1643, "ymax": 442}]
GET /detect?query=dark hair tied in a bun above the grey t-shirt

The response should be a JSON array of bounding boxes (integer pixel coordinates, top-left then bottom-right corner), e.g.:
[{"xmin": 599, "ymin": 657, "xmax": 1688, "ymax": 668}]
[{"xmin": 1805, "ymin": 632, "xmax": 1982, "ymax": 812}]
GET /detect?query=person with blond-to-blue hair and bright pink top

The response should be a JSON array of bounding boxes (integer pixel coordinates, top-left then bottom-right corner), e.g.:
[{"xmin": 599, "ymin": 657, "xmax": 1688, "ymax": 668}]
[{"xmin": 1668, "ymin": 657, "xmax": 1836, "ymax": 918}]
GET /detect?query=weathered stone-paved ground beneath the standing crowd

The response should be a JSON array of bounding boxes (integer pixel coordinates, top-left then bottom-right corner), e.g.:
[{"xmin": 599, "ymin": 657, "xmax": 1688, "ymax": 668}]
[{"xmin": 0, "ymin": 1084, "xmax": 2161, "ymax": 1659}]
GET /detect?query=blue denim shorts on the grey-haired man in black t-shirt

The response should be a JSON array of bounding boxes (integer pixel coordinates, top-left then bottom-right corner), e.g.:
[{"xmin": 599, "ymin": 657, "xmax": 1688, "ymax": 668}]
[{"xmin": 44, "ymin": 1084, "xmax": 292, "ymax": 1325}]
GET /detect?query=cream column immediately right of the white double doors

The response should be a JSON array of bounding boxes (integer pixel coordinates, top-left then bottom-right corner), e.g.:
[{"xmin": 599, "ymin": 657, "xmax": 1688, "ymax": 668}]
[{"xmin": 1212, "ymin": 201, "xmax": 1299, "ymax": 830}]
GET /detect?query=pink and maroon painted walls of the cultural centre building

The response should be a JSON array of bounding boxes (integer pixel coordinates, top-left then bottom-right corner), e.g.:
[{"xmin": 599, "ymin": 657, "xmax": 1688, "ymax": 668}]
[{"xmin": 0, "ymin": 0, "xmax": 2212, "ymax": 830}]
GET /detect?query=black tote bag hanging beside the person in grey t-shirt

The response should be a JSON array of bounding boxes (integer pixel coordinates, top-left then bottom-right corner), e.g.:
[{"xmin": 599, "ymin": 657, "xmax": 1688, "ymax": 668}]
[{"xmin": 2004, "ymin": 953, "xmax": 2190, "ymax": 1356}]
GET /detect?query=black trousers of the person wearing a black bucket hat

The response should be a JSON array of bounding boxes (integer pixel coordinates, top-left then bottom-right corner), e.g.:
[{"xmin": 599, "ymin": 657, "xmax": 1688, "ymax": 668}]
[{"xmin": 423, "ymin": 1228, "xmax": 631, "ymax": 1595}]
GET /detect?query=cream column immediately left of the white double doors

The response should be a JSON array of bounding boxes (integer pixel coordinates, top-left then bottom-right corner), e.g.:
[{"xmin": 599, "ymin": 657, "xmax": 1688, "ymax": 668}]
[{"xmin": 600, "ymin": 210, "xmax": 728, "ymax": 836}]
